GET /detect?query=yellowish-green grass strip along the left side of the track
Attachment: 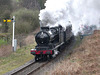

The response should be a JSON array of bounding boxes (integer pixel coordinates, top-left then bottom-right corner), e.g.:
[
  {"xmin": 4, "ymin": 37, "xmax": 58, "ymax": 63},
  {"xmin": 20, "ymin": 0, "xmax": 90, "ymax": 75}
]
[{"xmin": 0, "ymin": 44, "xmax": 35, "ymax": 75}]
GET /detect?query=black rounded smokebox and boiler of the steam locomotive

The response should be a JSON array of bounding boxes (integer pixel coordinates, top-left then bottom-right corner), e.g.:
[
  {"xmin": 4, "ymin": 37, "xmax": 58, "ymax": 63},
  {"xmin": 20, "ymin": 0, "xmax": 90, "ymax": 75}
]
[{"xmin": 35, "ymin": 27, "xmax": 59, "ymax": 45}]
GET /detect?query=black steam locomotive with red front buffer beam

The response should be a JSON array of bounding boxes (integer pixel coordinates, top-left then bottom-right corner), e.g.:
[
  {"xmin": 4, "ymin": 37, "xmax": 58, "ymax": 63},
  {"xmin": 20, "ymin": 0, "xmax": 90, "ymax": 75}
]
[{"xmin": 31, "ymin": 25, "xmax": 73, "ymax": 61}]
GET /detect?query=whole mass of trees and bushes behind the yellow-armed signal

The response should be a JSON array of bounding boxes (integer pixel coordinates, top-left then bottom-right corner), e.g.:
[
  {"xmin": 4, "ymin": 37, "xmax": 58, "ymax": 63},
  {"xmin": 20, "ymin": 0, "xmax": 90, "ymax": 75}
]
[{"xmin": 0, "ymin": 0, "xmax": 41, "ymax": 34}]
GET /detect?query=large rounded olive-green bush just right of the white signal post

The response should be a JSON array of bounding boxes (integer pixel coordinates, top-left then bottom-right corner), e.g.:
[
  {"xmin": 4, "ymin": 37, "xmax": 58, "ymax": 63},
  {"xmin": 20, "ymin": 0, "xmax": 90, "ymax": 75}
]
[{"xmin": 9, "ymin": 9, "xmax": 39, "ymax": 34}]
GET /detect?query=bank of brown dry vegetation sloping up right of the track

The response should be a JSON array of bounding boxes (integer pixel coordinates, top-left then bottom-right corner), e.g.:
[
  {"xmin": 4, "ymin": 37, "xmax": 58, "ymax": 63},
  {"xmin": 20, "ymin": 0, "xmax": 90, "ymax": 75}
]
[{"xmin": 47, "ymin": 31, "xmax": 100, "ymax": 75}]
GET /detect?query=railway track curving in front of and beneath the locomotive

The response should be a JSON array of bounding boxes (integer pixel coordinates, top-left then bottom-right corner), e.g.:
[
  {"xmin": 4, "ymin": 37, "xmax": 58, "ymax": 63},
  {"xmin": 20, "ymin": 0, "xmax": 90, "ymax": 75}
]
[{"xmin": 4, "ymin": 37, "xmax": 75, "ymax": 75}]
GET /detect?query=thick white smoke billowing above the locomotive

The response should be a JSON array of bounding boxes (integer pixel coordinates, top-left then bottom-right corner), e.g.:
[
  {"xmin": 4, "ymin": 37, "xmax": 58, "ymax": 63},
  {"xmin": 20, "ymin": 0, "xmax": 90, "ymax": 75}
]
[{"xmin": 39, "ymin": 0, "xmax": 100, "ymax": 33}]
